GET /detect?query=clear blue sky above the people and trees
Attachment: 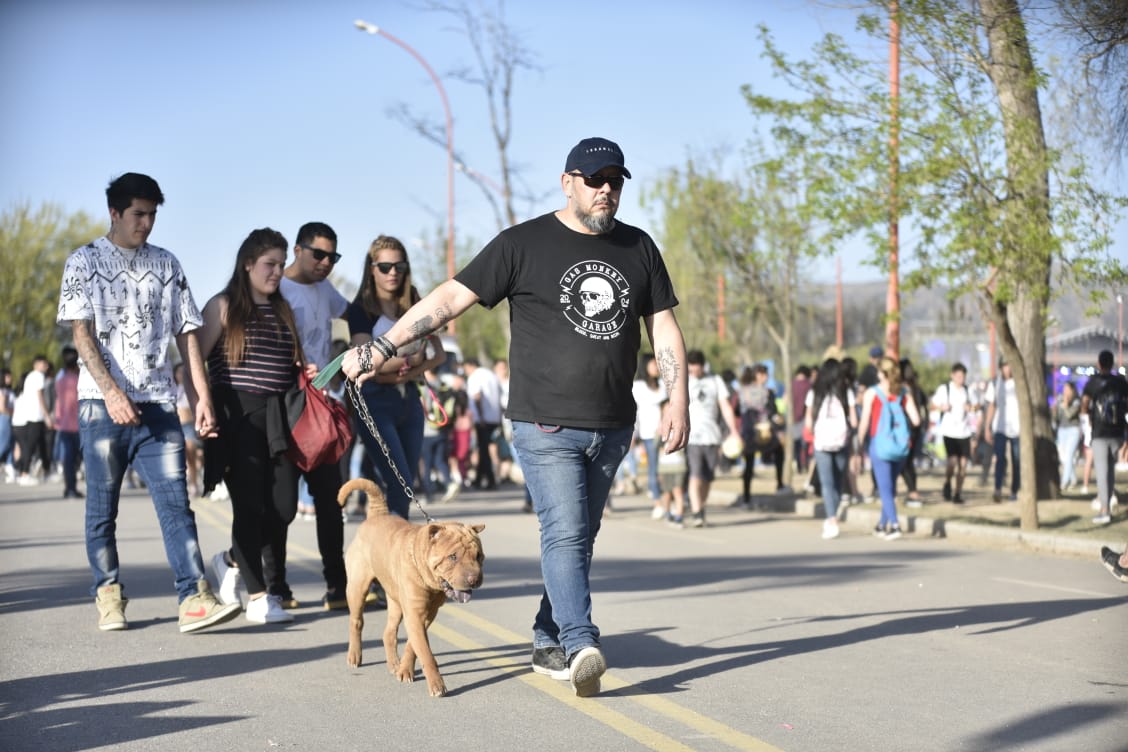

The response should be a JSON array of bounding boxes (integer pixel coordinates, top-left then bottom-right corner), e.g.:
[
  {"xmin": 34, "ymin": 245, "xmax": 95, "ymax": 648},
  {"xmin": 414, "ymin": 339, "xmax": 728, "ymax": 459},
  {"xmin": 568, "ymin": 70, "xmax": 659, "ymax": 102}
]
[{"xmin": 0, "ymin": 0, "xmax": 1128, "ymax": 306}]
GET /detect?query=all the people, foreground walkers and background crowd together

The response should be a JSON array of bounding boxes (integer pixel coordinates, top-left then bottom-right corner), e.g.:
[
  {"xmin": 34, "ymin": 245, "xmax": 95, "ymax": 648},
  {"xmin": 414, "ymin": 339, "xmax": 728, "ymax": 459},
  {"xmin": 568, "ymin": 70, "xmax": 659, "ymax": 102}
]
[{"xmin": 10, "ymin": 139, "xmax": 1128, "ymax": 697}]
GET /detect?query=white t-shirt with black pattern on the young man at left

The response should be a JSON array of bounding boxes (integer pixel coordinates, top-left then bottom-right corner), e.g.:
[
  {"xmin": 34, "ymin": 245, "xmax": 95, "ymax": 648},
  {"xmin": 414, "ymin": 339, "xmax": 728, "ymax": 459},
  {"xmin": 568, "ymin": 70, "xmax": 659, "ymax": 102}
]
[{"xmin": 56, "ymin": 238, "xmax": 203, "ymax": 402}]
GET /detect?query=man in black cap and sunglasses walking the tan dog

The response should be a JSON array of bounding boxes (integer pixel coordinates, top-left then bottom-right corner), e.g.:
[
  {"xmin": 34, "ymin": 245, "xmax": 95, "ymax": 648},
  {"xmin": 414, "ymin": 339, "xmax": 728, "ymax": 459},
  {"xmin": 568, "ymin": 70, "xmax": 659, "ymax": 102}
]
[{"xmin": 342, "ymin": 139, "xmax": 689, "ymax": 697}]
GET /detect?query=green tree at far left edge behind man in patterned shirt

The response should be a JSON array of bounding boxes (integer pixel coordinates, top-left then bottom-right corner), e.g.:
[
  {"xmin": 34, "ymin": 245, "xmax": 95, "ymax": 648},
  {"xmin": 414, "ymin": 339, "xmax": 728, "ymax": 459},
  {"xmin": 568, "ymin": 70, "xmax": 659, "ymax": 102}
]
[{"xmin": 0, "ymin": 203, "xmax": 108, "ymax": 379}]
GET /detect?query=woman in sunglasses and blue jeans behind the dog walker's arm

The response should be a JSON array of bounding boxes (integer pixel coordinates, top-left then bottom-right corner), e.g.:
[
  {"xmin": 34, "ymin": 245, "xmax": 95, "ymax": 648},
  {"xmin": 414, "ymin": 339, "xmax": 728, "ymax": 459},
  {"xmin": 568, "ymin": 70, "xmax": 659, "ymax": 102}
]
[{"xmin": 347, "ymin": 235, "xmax": 447, "ymax": 519}]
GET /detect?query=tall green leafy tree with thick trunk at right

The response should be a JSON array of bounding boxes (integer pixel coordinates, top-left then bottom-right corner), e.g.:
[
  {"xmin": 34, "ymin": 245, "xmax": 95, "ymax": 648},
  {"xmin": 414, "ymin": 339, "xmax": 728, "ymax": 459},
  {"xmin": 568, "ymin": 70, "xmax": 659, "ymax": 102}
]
[{"xmin": 744, "ymin": 0, "xmax": 1125, "ymax": 529}]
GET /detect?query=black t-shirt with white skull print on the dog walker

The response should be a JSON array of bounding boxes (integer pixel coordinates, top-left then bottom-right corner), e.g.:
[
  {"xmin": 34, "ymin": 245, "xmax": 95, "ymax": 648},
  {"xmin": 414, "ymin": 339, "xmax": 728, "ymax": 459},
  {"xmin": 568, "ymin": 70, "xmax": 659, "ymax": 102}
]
[{"xmin": 455, "ymin": 214, "xmax": 678, "ymax": 428}]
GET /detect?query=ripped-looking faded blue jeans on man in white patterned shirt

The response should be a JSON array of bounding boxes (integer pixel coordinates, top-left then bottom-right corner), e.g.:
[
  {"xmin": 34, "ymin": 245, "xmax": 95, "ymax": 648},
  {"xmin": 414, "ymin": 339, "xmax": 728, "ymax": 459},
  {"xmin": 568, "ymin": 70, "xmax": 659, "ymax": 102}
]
[{"xmin": 78, "ymin": 399, "xmax": 204, "ymax": 601}]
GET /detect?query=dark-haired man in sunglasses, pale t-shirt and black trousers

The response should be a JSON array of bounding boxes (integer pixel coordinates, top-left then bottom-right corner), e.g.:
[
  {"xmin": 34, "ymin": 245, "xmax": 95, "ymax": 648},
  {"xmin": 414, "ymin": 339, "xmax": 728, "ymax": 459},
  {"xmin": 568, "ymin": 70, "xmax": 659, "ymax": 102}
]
[{"xmin": 272, "ymin": 222, "xmax": 349, "ymax": 610}]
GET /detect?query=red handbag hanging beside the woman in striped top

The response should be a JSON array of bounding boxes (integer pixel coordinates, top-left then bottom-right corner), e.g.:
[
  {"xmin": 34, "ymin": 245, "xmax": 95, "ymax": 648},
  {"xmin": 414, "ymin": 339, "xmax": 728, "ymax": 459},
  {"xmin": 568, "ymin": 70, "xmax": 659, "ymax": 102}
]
[{"xmin": 285, "ymin": 371, "xmax": 353, "ymax": 472}]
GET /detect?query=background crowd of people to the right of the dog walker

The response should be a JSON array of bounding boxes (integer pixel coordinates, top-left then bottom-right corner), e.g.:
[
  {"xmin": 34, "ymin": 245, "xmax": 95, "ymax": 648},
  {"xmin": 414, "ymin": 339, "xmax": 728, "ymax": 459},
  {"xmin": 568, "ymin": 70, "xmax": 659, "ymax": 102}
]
[{"xmin": 619, "ymin": 347, "xmax": 1128, "ymax": 540}]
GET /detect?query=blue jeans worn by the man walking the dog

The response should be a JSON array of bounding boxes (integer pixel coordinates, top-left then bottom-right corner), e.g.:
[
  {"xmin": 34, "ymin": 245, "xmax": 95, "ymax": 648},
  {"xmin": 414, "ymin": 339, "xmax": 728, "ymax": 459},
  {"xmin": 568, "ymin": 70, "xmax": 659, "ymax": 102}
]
[{"xmin": 513, "ymin": 421, "xmax": 634, "ymax": 656}]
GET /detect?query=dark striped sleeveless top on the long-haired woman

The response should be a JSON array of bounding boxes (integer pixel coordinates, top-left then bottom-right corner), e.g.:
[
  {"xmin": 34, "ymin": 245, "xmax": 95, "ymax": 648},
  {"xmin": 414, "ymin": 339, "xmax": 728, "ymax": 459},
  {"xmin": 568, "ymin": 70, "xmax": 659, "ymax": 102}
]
[{"xmin": 208, "ymin": 303, "xmax": 296, "ymax": 395}]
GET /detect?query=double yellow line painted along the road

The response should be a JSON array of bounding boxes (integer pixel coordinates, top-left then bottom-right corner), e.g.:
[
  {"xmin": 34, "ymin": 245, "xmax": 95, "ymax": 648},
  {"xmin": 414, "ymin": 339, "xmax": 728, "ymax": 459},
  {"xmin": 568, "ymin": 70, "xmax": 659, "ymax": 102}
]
[{"xmin": 193, "ymin": 502, "xmax": 782, "ymax": 752}]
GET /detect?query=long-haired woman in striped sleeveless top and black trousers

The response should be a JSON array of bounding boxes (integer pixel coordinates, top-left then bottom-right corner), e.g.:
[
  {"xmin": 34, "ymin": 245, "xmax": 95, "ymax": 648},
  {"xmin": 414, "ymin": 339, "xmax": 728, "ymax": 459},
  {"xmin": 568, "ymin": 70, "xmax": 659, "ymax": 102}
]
[{"xmin": 200, "ymin": 228, "xmax": 301, "ymax": 623}]
